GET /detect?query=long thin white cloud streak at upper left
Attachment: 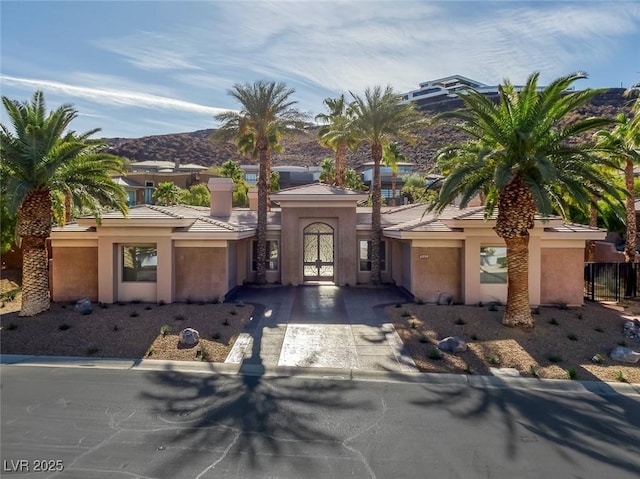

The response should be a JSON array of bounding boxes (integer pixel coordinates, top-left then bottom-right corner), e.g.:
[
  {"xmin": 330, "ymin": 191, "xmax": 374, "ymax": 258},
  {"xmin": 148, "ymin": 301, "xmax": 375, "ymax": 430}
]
[{"xmin": 0, "ymin": 75, "xmax": 235, "ymax": 115}]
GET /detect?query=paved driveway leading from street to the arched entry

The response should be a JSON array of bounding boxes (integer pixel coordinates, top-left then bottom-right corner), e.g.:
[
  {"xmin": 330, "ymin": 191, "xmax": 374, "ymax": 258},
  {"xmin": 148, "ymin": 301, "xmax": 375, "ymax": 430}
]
[{"xmin": 225, "ymin": 285, "xmax": 418, "ymax": 372}]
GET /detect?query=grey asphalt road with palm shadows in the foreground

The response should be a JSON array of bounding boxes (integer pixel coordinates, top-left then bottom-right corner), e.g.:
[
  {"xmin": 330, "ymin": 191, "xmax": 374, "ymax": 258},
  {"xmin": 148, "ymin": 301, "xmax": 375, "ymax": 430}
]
[{"xmin": 0, "ymin": 366, "xmax": 640, "ymax": 479}]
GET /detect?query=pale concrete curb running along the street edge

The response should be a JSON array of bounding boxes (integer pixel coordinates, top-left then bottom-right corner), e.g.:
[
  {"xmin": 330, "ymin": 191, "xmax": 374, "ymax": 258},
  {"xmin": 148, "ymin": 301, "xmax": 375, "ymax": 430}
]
[{"xmin": 0, "ymin": 354, "xmax": 640, "ymax": 396}]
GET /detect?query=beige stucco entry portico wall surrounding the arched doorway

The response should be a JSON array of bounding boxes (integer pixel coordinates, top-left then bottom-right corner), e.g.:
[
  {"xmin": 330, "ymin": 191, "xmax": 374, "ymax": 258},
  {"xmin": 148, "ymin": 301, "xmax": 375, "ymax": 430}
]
[{"xmin": 280, "ymin": 206, "xmax": 358, "ymax": 286}]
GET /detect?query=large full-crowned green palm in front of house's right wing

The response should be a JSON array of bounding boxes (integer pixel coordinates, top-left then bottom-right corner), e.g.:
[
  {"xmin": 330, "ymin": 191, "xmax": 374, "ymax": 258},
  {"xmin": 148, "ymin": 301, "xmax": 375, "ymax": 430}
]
[{"xmin": 431, "ymin": 73, "xmax": 620, "ymax": 329}]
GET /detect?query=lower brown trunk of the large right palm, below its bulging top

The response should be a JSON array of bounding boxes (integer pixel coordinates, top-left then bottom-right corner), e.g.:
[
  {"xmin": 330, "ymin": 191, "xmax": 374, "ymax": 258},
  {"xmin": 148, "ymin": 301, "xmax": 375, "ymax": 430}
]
[{"xmin": 502, "ymin": 235, "xmax": 534, "ymax": 329}]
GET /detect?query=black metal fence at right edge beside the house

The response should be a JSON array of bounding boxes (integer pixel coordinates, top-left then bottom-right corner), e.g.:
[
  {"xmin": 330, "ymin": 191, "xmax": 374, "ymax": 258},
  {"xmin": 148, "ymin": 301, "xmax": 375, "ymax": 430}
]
[{"xmin": 584, "ymin": 263, "xmax": 640, "ymax": 301}]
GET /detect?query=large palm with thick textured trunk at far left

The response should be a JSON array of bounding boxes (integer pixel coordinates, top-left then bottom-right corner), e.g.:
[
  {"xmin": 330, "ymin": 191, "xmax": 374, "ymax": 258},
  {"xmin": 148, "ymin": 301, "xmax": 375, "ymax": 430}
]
[{"xmin": 0, "ymin": 91, "xmax": 127, "ymax": 316}]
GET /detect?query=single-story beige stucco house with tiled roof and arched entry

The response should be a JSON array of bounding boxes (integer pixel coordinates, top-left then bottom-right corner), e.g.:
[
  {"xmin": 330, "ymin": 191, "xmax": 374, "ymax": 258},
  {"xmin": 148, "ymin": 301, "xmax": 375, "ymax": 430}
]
[{"xmin": 51, "ymin": 178, "xmax": 605, "ymax": 306}]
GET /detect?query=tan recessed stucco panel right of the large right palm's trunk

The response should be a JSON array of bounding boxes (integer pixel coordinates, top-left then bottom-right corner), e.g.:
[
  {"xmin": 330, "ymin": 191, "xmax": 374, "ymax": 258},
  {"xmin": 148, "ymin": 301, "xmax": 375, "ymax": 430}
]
[{"xmin": 540, "ymin": 247, "xmax": 584, "ymax": 306}]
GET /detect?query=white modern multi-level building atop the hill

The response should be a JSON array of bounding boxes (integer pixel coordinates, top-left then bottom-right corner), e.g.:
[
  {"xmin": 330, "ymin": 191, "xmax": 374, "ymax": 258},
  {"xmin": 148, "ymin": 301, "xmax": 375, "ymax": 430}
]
[{"xmin": 402, "ymin": 75, "xmax": 544, "ymax": 108}]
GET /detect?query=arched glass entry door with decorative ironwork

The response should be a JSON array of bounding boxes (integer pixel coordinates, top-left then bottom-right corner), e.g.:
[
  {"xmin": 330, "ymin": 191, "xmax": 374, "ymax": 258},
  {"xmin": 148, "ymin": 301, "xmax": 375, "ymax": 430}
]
[{"xmin": 303, "ymin": 223, "xmax": 333, "ymax": 281}]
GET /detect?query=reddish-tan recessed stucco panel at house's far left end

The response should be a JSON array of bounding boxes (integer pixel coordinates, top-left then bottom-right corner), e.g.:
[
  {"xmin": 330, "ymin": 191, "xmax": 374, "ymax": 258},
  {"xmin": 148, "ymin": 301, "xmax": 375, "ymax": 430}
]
[{"xmin": 51, "ymin": 246, "xmax": 98, "ymax": 301}]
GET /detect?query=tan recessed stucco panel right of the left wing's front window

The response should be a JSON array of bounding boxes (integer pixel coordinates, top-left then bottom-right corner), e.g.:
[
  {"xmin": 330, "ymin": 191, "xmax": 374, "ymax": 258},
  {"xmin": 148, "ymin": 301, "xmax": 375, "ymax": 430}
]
[{"xmin": 174, "ymin": 247, "xmax": 229, "ymax": 301}]
